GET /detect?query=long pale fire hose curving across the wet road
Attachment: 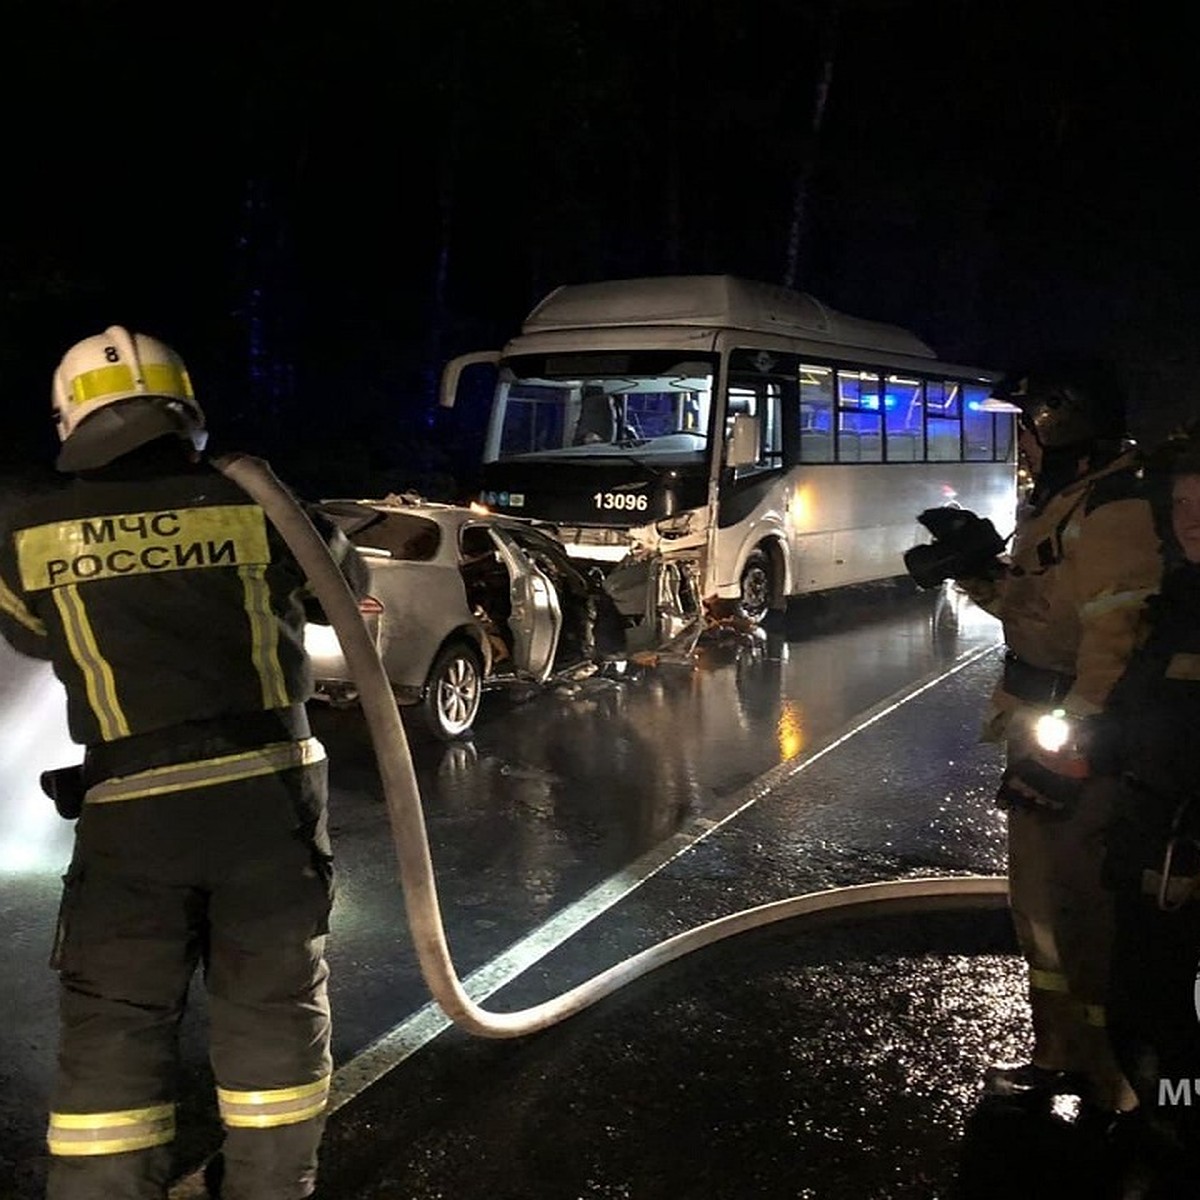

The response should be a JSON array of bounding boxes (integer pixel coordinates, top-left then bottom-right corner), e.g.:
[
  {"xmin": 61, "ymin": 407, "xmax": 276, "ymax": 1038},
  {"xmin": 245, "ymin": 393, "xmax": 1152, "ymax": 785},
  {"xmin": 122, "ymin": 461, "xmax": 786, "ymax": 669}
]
[{"xmin": 214, "ymin": 454, "xmax": 1008, "ymax": 1038}]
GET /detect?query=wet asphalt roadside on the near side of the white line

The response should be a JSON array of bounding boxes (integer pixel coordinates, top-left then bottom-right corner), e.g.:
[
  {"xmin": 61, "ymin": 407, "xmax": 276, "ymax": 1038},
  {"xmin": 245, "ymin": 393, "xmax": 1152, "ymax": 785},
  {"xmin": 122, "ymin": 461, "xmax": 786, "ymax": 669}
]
[{"xmin": 307, "ymin": 655, "xmax": 1032, "ymax": 1200}]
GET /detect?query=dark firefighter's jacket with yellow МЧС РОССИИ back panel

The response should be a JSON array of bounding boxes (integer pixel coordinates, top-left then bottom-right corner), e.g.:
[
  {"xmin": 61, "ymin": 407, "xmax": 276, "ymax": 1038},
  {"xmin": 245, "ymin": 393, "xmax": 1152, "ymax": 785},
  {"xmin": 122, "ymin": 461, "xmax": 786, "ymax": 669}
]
[{"xmin": 0, "ymin": 446, "xmax": 366, "ymax": 763}]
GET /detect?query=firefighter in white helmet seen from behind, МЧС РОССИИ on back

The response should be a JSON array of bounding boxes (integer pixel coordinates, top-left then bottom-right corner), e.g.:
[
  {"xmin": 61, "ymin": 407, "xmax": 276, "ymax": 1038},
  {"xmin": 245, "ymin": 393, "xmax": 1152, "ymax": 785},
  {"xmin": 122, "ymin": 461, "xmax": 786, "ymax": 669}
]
[{"xmin": 0, "ymin": 326, "xmax": 365, "ymax": 1200}]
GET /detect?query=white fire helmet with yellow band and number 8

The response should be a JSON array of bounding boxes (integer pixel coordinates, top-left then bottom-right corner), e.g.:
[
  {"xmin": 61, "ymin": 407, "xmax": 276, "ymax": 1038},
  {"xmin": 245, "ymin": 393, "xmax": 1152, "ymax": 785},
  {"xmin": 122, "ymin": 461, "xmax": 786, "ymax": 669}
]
[{"xmin": 50, "ymin": 325, "xmax": 206, "ymax": 472}]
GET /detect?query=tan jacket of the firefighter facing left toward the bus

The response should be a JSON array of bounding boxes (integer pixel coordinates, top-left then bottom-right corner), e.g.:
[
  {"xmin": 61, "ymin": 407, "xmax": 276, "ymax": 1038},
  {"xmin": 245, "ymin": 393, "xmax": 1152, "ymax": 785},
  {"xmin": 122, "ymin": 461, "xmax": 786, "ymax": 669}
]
[{"xmin": 960, "ymin": 452, "xmax": 1162, "ymax": 740}]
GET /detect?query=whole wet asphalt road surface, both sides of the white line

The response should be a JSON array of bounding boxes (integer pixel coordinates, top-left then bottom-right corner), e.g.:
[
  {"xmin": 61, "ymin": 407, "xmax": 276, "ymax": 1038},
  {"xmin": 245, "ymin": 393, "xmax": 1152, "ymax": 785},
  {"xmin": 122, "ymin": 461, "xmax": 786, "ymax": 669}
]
[{"xmin": 0, "ymin": 578, "xmax": 1051, "ymax": 1200}]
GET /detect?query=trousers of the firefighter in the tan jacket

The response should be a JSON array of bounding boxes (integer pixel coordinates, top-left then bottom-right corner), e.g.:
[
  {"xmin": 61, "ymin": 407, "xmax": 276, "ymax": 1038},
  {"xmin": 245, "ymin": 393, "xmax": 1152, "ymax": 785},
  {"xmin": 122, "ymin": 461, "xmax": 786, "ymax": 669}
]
[{"xmin": 1008, "ymin": 786, "xmax": 1136, "ymax": 1110}]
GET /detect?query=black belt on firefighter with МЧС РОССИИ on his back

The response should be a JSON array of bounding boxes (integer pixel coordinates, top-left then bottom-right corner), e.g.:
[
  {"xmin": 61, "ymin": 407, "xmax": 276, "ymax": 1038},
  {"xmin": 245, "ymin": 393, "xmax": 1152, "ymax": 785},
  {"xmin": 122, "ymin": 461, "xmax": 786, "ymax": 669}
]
[{"xmin": 83, "ymin": 704, "xmax": 310, "ymax": 787}]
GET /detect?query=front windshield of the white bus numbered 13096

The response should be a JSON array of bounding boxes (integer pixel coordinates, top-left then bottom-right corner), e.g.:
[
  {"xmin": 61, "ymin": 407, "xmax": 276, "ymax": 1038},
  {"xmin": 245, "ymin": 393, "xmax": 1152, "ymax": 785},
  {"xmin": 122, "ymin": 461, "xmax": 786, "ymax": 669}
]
[{"xmin": 484, "ymin": 350, "xmax": 714, "ymax": 462}]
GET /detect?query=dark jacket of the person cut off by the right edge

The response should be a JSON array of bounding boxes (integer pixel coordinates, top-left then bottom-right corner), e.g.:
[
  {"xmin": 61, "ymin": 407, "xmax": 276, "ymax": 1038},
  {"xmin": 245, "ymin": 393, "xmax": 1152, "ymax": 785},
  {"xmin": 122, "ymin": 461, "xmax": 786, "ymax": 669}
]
[{"xmin": 1090, "ymin": 563, "xmax": 1200, "ymax": 877}]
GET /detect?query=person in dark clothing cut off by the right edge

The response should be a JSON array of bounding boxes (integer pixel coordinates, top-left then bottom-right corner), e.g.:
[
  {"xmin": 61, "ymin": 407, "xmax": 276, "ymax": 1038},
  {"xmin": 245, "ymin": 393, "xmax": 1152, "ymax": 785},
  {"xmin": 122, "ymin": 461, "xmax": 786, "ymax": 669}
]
[{"xmin": 1086, "ymin": 428, "xmax": 1200, "ymax": 1200}]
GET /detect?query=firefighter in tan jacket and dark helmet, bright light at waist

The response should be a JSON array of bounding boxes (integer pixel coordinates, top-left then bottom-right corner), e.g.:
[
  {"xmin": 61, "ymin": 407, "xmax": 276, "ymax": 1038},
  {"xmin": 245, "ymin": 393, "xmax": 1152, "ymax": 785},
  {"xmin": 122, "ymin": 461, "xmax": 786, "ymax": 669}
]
[{"xmin": 906, "ymin": 368, "xmax": 1162, "ymax": 1120}]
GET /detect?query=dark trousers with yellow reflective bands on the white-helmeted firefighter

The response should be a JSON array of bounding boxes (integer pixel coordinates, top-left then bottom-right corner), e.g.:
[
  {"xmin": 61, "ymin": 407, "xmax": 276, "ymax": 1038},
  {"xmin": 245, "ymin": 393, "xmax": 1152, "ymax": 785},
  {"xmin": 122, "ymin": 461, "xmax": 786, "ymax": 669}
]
[{"xmin": 47, "ymin": 743, "xmax": 332, "ymax": 1200}]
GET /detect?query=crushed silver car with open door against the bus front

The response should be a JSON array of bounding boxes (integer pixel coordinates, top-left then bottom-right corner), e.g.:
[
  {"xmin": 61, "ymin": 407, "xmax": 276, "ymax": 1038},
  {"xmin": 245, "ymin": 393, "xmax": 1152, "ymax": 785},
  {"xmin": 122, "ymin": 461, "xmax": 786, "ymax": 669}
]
[{"xmin": 305, "ymin": 494, "xmax": 703, "ymax": 740}]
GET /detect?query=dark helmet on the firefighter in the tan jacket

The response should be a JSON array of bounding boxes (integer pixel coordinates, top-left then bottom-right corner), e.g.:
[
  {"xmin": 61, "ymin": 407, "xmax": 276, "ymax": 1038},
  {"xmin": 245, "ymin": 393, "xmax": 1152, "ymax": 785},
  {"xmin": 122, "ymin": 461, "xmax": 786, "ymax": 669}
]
[{"xmin": 992, "ymin": 367, "xmax": 1127, "ymax": 450}]
